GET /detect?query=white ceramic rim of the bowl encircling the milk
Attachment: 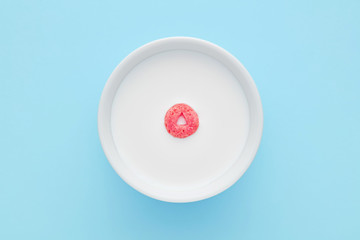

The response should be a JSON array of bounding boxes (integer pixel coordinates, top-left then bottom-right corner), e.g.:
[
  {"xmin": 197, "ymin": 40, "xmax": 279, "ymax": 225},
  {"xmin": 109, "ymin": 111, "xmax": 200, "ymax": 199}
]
[{"xmin": 98, "ymin": 37, "xmax": 263, "ymax": 202}]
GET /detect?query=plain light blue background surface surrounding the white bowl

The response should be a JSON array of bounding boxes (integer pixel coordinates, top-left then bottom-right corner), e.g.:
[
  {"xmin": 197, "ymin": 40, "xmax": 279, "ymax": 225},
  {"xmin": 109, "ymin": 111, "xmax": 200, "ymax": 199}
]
[{"xmin": 0, "ymin": 0, "xmax": 360, "ymax": 240}]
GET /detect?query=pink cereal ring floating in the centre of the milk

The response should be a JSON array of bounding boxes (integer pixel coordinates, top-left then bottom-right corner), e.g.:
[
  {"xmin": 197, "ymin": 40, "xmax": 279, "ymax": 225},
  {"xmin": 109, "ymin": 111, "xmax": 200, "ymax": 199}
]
[{"xmin": 165, "ymin": 103, "xmax": 199, "ymax": 138}]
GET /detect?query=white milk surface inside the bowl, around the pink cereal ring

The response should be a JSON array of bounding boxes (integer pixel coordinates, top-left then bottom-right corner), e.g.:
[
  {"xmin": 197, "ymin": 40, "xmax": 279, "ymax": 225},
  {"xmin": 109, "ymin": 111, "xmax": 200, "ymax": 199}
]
[{"xmin": 111, "ymin": 50, "xmax": 249, "ymax": 191}]
